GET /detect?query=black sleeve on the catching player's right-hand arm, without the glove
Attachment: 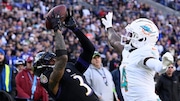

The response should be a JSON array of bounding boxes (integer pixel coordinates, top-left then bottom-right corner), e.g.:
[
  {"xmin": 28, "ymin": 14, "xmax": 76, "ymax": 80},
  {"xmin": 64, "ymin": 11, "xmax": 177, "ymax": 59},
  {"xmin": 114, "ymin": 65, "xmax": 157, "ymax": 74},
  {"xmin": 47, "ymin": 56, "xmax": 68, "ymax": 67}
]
[{"xmin": 73, "ymin": 28, "xmax": 95, "ymax": 73}]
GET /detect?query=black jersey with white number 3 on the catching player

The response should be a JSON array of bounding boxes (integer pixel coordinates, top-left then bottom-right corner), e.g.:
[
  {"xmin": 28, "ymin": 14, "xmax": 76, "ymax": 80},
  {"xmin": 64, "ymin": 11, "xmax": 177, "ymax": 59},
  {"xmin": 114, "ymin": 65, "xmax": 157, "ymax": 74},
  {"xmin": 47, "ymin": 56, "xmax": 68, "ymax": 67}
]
[{"xmin": 41, "ymin": 63, "xmax": 99, "ymax": 101}]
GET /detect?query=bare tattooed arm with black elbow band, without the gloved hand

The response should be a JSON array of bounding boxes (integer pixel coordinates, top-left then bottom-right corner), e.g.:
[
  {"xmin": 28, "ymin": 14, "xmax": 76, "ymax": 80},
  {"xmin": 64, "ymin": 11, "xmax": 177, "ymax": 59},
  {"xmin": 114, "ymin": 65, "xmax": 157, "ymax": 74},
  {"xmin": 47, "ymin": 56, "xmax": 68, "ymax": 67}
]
[{"xmin": 49, "ymin": 30, "xmax": 68, "ymax": 94}]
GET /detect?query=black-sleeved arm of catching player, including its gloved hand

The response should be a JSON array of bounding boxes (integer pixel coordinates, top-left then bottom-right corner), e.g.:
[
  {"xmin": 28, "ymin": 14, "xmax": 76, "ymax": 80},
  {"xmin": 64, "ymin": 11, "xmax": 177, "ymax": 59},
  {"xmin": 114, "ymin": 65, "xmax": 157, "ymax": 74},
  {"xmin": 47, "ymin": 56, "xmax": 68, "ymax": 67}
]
[{"xmin": 65, "ymin": 16, "xmax": 95, "ymax": 73}]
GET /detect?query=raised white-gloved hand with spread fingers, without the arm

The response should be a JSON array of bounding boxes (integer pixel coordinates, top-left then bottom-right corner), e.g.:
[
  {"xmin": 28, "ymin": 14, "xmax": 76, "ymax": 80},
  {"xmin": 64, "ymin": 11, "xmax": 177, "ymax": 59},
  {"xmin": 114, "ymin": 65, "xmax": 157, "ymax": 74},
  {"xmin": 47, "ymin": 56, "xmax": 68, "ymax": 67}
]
[{"xmin": 101, "ymin": 12, "xmax": 113, "ymax": 31}]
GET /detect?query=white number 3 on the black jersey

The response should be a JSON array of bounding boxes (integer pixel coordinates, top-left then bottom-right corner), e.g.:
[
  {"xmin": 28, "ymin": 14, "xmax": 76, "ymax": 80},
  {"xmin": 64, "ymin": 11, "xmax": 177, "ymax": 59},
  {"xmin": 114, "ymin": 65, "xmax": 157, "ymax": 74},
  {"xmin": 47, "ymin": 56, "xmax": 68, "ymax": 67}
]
[{"xmin": 73, "ymin": 75, "xmax": 92, "ymax": 96}]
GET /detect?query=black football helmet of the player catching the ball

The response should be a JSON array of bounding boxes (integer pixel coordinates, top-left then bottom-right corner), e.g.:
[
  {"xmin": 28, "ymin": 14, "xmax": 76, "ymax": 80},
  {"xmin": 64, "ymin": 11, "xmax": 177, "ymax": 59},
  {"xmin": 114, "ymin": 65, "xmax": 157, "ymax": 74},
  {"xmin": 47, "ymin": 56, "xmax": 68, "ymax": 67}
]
[{"xmin": 33, "ymin": 52, "xmax": 56, "ymax": 77}]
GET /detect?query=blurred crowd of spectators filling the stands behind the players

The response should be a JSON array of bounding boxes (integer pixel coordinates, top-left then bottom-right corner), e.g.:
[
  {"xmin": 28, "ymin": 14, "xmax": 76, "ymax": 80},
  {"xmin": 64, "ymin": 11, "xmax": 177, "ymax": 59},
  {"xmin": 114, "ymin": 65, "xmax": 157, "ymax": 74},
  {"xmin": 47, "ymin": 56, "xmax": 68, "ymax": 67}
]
[{"xmin": 0, "ymin": 0, "xmax": 180, "ymax": 68}]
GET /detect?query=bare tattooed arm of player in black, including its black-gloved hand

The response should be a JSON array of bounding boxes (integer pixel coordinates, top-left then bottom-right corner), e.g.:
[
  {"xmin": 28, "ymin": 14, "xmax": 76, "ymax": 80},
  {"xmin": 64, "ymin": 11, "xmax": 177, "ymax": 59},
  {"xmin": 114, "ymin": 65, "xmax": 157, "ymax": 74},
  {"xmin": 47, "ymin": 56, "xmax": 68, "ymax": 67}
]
[{"xmin": 47, "ymin": 12, "xmax": 68, "ymax": 95}]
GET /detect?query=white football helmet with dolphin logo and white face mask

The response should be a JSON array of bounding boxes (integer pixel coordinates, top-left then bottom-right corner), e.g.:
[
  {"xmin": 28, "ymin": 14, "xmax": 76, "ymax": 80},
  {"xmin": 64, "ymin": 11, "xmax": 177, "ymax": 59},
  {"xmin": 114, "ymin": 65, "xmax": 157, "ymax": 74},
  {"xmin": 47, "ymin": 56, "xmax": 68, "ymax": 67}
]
[{"xmin": 121, "ymin": 18, "xmax": 159, "ymax": 48}]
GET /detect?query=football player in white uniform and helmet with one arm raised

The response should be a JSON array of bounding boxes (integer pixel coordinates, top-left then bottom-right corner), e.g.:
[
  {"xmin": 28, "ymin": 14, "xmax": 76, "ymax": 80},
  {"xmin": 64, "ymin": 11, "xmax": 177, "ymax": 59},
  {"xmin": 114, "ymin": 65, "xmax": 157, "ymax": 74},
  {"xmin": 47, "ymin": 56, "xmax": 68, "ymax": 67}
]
[{"xmin": 102, "ymin": 12, "xmax": 174, "ymax": 101}]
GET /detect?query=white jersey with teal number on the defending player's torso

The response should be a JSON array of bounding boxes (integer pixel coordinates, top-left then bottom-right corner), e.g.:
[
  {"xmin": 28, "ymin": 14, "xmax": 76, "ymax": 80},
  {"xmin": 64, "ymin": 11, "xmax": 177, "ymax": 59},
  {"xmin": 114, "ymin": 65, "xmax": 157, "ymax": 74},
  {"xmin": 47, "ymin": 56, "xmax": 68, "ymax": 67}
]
[{"xmin": 120, "ymin": 46, "xmax": 159, "ymax": 101}]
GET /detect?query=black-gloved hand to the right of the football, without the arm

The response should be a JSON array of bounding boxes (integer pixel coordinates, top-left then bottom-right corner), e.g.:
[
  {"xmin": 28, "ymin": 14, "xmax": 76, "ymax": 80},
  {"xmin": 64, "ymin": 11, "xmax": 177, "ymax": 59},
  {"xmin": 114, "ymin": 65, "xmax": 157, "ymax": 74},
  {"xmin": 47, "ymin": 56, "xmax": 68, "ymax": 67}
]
[{"xmin": 64, "ymin": 9, "xmax": 77, "ymax": 30}]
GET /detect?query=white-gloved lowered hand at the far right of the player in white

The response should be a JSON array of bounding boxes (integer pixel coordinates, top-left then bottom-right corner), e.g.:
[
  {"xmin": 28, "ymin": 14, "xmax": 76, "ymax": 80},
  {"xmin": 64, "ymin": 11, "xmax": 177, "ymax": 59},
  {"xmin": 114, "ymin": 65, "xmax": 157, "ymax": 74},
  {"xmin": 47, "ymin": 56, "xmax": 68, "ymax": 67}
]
[{"xmin": 162, "ymin": 52, "xmax": 174, "ymax": 67}]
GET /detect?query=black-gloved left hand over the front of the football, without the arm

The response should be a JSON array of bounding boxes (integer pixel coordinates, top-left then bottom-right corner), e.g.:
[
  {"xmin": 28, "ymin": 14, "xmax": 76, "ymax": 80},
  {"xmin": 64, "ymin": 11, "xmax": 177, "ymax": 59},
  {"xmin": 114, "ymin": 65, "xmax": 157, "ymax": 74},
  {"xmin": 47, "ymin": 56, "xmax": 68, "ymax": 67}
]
[{"xmin": 47, "ymin": 11, "xmax": 62, "ymax": 31}]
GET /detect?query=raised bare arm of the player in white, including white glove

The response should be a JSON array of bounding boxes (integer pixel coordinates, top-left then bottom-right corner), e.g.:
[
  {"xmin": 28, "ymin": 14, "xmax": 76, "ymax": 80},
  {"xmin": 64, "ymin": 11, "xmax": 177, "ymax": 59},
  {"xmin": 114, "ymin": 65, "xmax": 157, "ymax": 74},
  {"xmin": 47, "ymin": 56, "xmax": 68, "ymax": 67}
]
[{"xmin": 102, "ymin": 12, "xmax": 124, "ymax": 55}]
